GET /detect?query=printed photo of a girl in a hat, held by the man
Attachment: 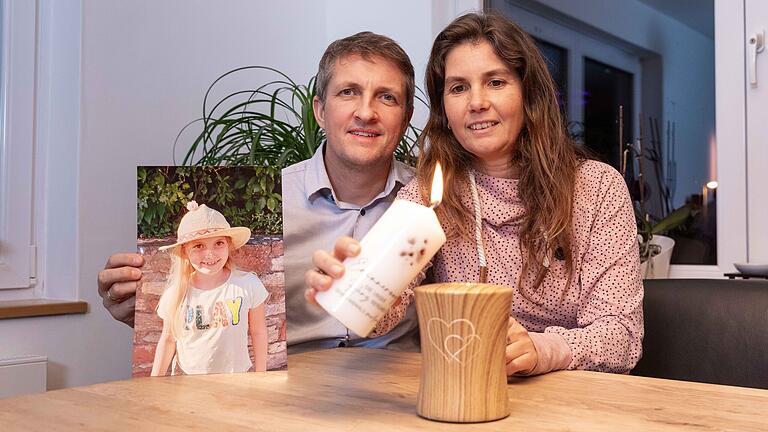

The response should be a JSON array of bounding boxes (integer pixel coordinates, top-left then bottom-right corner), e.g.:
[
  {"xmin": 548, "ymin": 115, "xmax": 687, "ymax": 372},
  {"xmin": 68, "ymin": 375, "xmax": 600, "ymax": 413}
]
[{"xmin": 133, "ymin": 167, "xmax": 287, "ymax": 376}]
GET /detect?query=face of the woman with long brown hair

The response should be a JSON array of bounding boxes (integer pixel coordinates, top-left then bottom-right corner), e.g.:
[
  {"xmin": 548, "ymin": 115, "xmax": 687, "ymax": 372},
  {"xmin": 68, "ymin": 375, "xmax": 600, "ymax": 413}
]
[{"xmin": 443, "ymin": 41, "xmax": 525, "ymax": 177}]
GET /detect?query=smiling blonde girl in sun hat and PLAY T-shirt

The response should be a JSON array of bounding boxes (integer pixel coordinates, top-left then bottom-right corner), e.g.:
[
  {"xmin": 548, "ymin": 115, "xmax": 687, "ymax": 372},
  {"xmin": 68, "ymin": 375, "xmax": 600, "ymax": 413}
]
[{"xmin": 151, "ymin": 201, "xmax": 269, "ymax": 376}]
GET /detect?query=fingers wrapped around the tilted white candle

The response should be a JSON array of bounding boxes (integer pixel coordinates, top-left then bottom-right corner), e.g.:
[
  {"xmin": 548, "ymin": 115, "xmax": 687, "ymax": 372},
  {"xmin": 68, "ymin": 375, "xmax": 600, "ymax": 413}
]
[{"xmin": 304, "ymin": 237, "xmax": 360, "ymax": 304}]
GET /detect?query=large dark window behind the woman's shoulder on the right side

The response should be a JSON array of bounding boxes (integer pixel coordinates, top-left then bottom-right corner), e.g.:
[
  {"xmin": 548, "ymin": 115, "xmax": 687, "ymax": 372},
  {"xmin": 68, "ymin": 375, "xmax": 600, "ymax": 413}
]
[{"xmin": 489, "ymin": 0, "xmax": 720, "ymax": 277}]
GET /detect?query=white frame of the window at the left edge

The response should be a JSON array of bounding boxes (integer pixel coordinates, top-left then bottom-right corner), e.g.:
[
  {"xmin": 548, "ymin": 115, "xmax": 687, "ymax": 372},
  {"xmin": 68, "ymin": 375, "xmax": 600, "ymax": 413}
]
[{"xmin": 0, "ymin": 0, "xmax": 83, "ymax": 302}]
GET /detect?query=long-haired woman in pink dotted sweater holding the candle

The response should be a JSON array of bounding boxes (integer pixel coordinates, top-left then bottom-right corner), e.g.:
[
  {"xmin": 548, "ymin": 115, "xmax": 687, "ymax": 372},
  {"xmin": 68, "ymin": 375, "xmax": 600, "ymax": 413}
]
[{"xmin": 307, "ymin": 14, "xmax": 643, "ymax": 375}]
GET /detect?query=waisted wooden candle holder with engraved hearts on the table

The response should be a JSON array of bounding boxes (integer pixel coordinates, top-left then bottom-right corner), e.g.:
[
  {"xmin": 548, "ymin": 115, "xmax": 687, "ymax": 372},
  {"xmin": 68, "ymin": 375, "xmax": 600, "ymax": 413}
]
[{"xmin": 415, "ymin": 283, "xmax": 512, "ymax": 423}]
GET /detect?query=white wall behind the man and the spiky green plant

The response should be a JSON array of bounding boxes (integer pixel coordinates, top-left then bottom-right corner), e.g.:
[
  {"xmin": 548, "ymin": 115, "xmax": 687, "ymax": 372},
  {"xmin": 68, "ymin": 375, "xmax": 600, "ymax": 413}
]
[{"xmin": 0, "ymin": 0, "xmax": 480, "ymax": 389}]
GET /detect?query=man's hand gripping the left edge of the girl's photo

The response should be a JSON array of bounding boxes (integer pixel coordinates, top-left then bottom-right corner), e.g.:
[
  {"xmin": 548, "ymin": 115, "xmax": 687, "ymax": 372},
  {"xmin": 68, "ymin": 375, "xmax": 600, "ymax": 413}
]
[{"xmin": 98, "ymin": 253, "xmax": 144, "ymax": 327}]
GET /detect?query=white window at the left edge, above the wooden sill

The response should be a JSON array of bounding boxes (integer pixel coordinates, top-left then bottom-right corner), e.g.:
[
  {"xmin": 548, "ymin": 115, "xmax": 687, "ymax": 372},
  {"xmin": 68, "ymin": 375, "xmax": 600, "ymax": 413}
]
[{"xmin": 0, "ymin": 0, "xmax": 83, "ymax": 301}]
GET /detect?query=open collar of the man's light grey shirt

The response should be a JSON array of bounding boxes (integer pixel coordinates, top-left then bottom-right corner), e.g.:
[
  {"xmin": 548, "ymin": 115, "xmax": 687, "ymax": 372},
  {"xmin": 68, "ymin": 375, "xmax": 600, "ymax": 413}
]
[{"xmin": 304, "ymin": 143, "xmax": 413, "ymax": 207}]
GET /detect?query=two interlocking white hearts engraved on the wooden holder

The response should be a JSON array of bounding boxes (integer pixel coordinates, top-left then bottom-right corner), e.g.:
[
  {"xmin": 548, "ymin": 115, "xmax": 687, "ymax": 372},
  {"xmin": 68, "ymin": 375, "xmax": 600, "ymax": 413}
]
[{"xmin": 427, "ymin": 318, "xmax": 481, "ymax": 365}]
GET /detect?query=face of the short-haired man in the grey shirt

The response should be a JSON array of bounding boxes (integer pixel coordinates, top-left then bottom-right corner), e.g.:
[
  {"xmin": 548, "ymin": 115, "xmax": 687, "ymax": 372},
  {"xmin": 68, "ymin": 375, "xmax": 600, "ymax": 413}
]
[{"xmin": 313, "ymin": 55, "xmax": 411, "ymax": 171}]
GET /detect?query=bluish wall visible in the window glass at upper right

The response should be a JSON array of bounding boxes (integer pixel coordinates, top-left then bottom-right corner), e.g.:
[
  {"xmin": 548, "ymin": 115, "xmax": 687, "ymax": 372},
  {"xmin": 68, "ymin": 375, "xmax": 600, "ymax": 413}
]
[{"xmin": 494, "ymin": 0, "xmax": 716, "ymax": 206}]
